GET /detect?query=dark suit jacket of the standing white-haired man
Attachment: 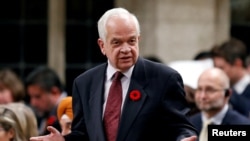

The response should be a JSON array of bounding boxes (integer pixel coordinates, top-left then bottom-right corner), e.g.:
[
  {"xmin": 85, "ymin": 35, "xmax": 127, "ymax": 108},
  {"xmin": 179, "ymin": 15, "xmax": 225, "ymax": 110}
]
[{"xmin": 65, "ymin": 58, "xmax": 197, "ymax": 141}]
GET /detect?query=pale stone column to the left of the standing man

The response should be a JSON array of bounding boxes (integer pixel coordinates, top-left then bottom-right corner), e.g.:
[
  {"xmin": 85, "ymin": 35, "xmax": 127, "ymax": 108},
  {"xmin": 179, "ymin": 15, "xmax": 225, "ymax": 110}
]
[{"xmin": 48, "ymin": 0, "xmax": 66, "ymax": 82}]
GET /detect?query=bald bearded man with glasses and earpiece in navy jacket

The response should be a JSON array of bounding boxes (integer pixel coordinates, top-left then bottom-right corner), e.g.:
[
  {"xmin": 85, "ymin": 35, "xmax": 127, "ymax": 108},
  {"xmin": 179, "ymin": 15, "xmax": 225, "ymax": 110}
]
[{"xmin": 190, "ymin": 68, "xmax": 250, "ymax": 141}]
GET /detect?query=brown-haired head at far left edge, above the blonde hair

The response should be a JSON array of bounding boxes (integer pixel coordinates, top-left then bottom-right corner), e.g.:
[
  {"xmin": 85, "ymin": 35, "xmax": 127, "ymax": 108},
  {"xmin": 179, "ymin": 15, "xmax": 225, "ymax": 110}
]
[{"xmin": 0, "ymin": 68, "xmax": 25, "ymax": 104}]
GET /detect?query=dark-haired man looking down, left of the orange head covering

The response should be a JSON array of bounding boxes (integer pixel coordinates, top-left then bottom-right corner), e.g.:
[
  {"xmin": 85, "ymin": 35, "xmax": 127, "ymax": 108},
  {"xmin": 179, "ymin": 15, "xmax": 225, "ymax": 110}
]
[{"xmin": 25, "ymin": 66, "xmax": 67, "ymax": 135}]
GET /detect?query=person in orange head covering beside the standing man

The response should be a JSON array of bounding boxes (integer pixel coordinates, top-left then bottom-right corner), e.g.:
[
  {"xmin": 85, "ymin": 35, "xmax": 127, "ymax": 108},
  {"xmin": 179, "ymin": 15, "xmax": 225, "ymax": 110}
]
[{"xmin": 57, "ymin": 96, "xmax": 73, "ymax": 135}]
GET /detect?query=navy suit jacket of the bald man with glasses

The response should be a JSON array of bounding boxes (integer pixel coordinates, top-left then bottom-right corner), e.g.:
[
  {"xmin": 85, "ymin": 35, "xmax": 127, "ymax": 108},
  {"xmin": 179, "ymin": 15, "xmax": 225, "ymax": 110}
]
[{"xmin": 190, "ymin": 108, "xmax": 250, "ymax": 133}]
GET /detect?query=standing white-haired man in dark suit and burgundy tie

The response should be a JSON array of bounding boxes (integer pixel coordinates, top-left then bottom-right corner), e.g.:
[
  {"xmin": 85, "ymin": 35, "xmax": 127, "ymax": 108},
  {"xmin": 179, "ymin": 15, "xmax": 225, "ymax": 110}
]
[{"xmin": 31, "ymin": 8, "xmax": 197, "ymax": 141}]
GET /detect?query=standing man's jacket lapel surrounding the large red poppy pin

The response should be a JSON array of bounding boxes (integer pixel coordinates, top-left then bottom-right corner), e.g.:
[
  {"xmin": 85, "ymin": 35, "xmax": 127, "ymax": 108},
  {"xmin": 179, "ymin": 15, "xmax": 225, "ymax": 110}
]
[{"xmin": 117, "ymin": 58, "xmax": 147, "ymax": 140}]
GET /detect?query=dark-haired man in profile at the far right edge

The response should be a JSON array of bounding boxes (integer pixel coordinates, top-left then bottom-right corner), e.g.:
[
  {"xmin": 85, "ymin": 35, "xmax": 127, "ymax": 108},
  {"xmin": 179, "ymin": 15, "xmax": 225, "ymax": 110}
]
[{"xmin": 211, "ymin": 38, "xmax": 250, "ymax": 118}]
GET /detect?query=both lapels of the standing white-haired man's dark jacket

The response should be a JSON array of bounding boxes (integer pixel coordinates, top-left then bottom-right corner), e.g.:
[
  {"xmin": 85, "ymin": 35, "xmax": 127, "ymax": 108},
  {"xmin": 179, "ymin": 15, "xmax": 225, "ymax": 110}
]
[{"xmin": 89, "ymin": 58, "xmax": 148, "ymax": 140}]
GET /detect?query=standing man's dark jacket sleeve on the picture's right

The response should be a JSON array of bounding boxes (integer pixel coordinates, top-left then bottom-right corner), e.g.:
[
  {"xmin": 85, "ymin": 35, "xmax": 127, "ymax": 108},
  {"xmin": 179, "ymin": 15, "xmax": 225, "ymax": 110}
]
[{"xmin": 163, "ymin": 73, "xmax": 197, "ymax": 140}]
